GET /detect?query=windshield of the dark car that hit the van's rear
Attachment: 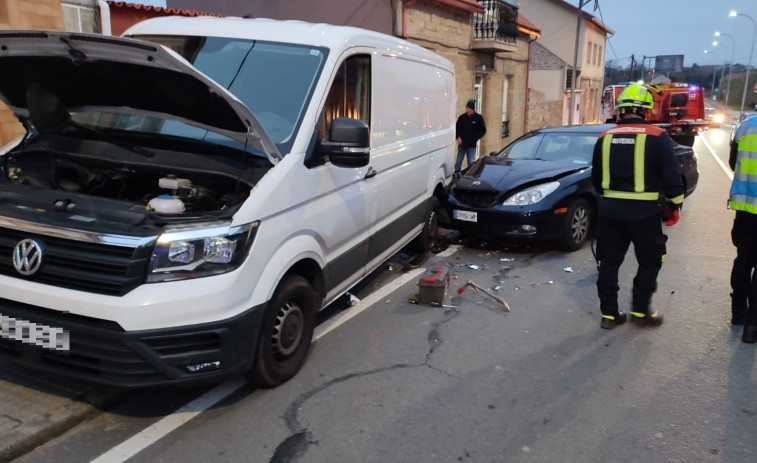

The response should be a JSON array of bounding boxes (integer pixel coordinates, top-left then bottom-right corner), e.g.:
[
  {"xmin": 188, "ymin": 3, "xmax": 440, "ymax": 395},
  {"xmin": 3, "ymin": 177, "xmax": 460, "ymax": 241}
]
[{"xmin": 497, "ymin": 132, "xmax": 599, "ymax": 165}]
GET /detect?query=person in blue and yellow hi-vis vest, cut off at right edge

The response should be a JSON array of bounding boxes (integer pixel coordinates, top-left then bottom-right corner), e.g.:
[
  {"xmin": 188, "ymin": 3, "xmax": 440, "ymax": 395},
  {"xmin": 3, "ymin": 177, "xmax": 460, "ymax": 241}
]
[{"xmin": 728, "ymin": 116, "xmax": 757, "ymax": 344}]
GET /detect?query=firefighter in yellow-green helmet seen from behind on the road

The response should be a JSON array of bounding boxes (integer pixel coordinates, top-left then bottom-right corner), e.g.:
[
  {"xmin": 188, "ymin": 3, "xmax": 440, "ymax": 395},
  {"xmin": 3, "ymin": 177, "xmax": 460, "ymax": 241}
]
[{"xmin": 591, "ymin": 84, "xmax": 683, "ymax": 329}]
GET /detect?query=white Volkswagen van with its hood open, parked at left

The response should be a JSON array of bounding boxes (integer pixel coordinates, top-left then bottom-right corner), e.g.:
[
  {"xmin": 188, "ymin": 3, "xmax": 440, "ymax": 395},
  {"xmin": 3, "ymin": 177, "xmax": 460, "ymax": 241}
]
[{"xmin": 0, "ymin": 17, "xmax": 455, "ymax": 387}]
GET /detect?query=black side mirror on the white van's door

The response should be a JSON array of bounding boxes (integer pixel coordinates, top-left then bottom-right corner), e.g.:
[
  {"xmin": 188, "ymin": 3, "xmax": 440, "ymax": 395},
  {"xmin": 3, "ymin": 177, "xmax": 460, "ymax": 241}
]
[{"xmin": 321, "ymin": 117, "xmax": 371, "ymax": 167}]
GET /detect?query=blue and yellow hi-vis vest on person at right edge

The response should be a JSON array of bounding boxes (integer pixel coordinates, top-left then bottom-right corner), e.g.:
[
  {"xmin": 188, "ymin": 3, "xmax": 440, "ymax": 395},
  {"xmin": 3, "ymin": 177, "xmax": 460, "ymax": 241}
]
[{"xmin": 728, "ymin": 117, "xmax": 757, "ymax": 214}]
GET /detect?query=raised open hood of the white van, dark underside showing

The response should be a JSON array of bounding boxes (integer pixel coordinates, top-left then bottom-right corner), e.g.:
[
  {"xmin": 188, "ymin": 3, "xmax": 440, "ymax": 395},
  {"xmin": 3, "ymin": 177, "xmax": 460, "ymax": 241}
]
[{"xmin": 0, "ymin": 31, "xmax": 281, "ymax": 164}]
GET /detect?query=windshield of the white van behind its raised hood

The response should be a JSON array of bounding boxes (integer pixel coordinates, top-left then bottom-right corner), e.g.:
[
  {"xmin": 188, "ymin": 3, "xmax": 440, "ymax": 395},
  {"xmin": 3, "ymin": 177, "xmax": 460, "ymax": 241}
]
[{"xmin": 136, "ymin": 35, "xmax": 328, "ymax": 155}]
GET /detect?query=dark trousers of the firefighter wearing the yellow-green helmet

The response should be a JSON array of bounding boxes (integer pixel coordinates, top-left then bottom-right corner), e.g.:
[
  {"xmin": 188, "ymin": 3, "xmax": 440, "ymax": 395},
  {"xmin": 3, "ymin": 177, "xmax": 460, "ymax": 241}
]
[{"xmin": 597, "ymin": 214, "xmax": 668, "ymax": 317}]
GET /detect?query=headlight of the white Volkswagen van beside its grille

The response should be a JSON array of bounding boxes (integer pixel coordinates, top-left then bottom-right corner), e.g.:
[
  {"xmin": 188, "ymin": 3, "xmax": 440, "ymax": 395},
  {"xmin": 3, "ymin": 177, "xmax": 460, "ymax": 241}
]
[{"xmin": 147, "ymin": 222, "xmax": 259, "ymax": 283}]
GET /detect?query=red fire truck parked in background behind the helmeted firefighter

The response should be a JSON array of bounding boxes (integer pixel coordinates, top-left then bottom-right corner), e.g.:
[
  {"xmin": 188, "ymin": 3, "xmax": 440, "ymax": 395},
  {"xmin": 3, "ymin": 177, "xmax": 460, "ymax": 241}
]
[{"xmin": 602, "ymin": 82, "xmax": 707, "ymax": 146}]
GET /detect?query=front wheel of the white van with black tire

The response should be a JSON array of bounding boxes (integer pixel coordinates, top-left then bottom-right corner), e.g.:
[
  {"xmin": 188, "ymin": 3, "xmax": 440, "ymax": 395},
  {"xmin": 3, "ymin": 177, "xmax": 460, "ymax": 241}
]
[{"xmin": 250, "ymin": 275, "xmax": 317, "ymax": 388}]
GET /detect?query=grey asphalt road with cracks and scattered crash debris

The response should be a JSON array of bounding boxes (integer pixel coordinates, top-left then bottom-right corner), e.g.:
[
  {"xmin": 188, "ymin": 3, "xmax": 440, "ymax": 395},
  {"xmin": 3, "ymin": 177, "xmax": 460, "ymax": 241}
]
[{"xmin": 5, "ymin": 127, "xmax": 757, "ymax": 463}]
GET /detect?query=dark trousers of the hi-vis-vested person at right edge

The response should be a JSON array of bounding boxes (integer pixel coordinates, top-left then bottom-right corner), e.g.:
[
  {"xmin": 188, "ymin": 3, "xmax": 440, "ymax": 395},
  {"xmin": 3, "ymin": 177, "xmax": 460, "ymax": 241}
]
[{"xmin": 731, "ymin": 211, "xmax": 757, "ymax": 325}]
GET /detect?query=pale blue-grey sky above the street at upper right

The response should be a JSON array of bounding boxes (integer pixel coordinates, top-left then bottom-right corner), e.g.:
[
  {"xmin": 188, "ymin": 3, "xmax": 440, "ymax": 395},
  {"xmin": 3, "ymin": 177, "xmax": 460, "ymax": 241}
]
[{"xmin": 564, "ymin": 0, "xmax": 757, "ymax": 67}]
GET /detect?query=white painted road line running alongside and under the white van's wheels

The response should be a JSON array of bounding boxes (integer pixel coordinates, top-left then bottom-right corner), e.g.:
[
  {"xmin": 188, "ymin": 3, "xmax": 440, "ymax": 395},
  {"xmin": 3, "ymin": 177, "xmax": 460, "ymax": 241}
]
[{"xmin": 86, "ymin": 246, "xmax": 460, "ymax": 463}]
